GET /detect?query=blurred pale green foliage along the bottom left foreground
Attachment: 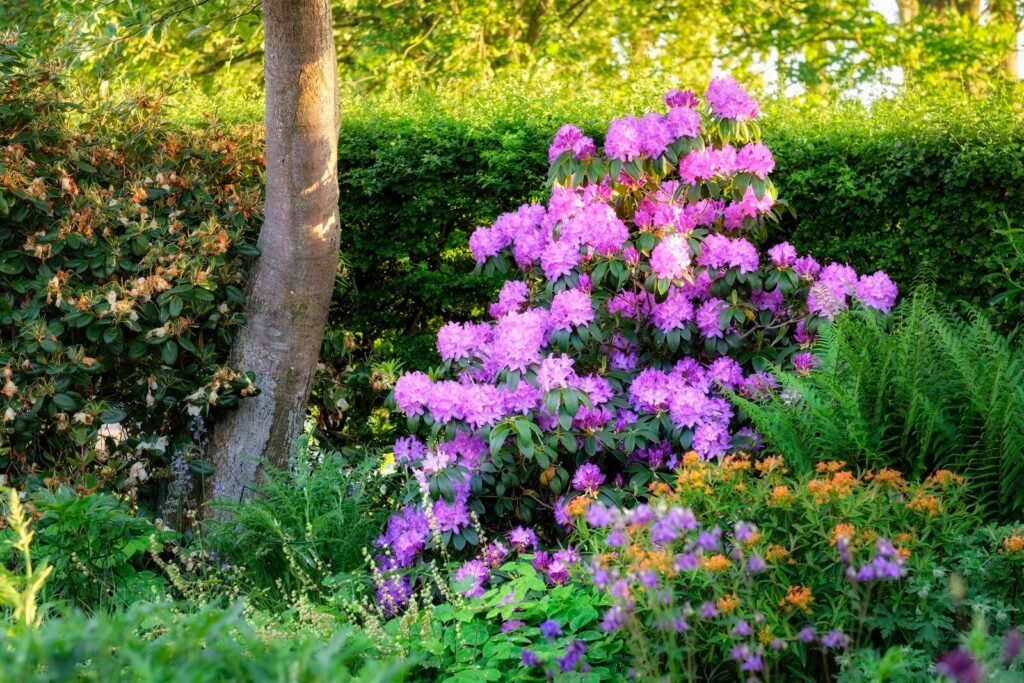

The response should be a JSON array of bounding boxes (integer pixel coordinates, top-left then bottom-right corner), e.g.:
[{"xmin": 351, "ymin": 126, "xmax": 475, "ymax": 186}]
[{"xmin": 0, "ymin": 603, "xmax": 414, "ymax": 683}]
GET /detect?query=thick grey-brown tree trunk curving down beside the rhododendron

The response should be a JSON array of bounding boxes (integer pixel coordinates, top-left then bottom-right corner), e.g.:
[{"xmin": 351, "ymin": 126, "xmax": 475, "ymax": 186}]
[{"xmin": 206, "ymin": 0, "xmax": 339, "ymax": 500}]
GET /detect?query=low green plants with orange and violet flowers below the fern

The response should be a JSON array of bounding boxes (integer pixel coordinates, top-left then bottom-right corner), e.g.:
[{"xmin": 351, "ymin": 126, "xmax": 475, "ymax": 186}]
[{"xmin": 582, "ymin": 456, "xmax": 1024, "ymax": 681}]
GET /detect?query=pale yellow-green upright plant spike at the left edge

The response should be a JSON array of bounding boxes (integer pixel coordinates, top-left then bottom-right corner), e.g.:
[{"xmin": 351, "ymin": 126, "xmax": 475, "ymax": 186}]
[{"xmin": 0, "ymin": 488, "xmax": 53, "ymax": 628}]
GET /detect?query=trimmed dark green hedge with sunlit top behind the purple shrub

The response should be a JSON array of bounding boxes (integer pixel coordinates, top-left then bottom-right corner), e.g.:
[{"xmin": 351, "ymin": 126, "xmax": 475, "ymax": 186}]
[{"xmin": 333, "ymin": 89, "xmax": 1024, "ymax": 378}]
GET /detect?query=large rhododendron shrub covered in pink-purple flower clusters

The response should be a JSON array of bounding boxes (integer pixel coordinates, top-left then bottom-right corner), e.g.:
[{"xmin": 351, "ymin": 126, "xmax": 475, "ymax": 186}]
[{"xmin": 380, "ymin": 79, "xmax": 896, "ymax": 575}]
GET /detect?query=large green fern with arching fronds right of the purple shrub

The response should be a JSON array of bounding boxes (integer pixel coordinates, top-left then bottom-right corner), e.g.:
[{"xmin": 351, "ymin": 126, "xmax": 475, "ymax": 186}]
[{"xmin": 734, "ymin": 290, "xmax": 1024, "ymax": 517}]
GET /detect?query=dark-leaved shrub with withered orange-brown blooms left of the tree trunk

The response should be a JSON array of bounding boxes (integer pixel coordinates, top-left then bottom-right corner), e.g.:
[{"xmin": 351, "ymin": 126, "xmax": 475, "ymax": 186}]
[{"xmin": 0, "ymin": 40, "xmax": 262, "ymax": 483}]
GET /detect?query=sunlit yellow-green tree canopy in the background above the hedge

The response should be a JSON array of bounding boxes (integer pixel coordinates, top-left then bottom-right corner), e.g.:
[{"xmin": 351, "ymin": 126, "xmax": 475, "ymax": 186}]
[{"xmin": 0, "ymin": 0, "xmax": 1024, "ymax": 95}]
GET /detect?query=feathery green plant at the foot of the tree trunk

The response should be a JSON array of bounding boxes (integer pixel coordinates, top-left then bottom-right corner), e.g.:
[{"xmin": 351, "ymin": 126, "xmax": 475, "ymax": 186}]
[{"xmin": 203, "ymin": 437, "xmax": 389, "ymax": 604}]
